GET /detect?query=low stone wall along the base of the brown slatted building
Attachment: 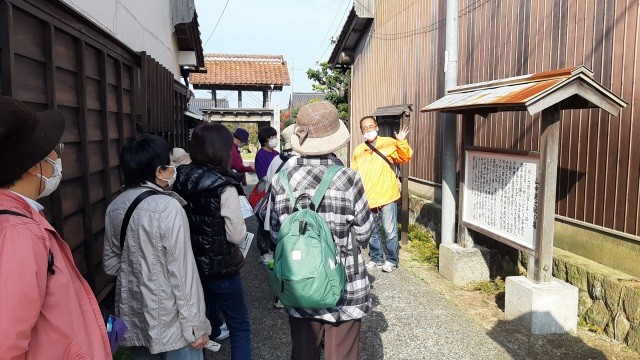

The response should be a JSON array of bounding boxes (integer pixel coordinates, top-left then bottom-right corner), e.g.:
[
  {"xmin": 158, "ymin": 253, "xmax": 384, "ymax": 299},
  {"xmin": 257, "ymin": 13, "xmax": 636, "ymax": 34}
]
[{"xmin": 409, "ymin": 193, "xmax": 640, "ymax": 352}]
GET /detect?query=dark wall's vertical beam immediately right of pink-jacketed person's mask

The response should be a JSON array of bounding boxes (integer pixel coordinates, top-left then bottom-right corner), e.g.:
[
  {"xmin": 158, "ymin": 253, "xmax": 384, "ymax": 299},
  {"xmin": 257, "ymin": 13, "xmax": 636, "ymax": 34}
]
[{"xmin": 76, "ymin": 40, "xmax": 95, "ymax": 290}]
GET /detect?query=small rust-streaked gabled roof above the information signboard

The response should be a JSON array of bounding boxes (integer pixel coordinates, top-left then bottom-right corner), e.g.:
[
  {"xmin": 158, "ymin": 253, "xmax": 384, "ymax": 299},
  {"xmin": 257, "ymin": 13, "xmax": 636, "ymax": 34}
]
[{"xmin": 421, "ymin": 66, "xmax": 627, "ymax": 115}]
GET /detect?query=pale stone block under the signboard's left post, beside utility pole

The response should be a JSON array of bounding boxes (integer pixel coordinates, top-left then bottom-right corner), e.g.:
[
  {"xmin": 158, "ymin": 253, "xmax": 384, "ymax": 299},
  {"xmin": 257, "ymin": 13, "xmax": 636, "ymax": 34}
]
[{"xmin": 439, "ymin": 244, "xmax": 490, "ymax": 285}]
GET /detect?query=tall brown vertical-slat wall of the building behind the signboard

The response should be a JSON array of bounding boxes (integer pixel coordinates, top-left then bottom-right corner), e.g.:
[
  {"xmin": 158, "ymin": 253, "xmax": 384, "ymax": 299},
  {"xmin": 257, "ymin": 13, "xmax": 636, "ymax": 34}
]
[{"xmin": 351, "ymin": 0, "xmax": 640, "ymax": 236}]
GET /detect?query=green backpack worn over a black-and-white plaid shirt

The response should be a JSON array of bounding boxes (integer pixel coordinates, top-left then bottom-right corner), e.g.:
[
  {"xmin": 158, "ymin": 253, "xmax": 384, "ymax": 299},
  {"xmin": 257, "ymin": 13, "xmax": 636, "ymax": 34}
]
[{"xmin": 268, "ymin": 165, "xmax": 346, "ymax": 309}]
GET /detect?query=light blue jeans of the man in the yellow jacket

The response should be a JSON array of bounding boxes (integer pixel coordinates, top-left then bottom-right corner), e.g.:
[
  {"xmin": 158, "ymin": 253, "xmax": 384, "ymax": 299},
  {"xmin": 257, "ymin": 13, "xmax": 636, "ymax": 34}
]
[{"xmin": 369, "ymin": 201, "xmax": 398, "ymax": 265}]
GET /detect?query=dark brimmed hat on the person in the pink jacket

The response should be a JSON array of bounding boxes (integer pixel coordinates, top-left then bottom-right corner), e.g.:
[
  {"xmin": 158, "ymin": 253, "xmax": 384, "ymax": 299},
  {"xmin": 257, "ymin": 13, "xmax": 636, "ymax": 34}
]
[{"xmin": 0, "ymin": 96, "xmax": 64, "ymax": 182}]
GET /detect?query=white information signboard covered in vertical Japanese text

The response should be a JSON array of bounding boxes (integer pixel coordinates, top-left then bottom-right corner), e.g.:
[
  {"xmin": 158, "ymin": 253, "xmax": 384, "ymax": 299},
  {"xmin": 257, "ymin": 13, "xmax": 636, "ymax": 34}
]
[{"xmin": 462, "ymin": 150, "xmax": 540, "ymax": 253}]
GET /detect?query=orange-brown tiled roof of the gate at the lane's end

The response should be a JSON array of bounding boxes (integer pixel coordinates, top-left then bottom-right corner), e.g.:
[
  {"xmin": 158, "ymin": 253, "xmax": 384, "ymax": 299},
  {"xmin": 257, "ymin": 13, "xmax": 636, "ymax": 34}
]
[{"xmin": 189, "ymin": 54, "xmax": 291, "ymax": 86}]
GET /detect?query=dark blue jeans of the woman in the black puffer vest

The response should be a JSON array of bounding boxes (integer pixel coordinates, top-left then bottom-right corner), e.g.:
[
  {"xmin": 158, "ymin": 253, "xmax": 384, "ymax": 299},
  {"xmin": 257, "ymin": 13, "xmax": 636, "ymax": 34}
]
[{"xmin": 202, "ymin": 273, "xmax": 251, "ymax": 360}]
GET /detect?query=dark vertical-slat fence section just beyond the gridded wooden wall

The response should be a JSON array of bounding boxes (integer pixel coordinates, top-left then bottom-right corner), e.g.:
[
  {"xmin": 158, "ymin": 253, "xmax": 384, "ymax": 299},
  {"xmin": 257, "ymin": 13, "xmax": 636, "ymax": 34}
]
[{"xmin": 138, "ymin": 52, "xmax": 189, "ymax": 148}]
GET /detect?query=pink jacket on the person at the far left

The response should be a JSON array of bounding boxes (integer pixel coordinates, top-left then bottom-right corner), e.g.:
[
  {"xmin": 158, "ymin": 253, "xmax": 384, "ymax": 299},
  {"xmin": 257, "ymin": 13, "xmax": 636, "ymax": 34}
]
[{"xmin": 0, "ymin": 189, "xmax": 111, "ymax": 360}]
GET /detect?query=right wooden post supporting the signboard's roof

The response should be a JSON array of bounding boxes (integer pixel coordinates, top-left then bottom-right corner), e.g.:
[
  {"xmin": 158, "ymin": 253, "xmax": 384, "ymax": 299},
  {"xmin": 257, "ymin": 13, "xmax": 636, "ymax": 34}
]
[{"xmin": 527, "ymin": 105, "xmax": 560, "ymax": 283}]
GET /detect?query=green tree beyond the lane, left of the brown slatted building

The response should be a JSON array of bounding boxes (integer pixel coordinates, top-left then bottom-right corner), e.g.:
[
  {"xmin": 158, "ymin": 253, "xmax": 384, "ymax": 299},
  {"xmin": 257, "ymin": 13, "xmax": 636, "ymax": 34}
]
[{"xmin": 307, "ymin": 62, "xmax": 351, "ymax": 121}]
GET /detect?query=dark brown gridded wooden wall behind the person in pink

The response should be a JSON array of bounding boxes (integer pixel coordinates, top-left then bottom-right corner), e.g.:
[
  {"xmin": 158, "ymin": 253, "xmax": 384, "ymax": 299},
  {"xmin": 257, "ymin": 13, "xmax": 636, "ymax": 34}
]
[{"xmin": 0, "ymin": 1, "xmax": 136, "ymax": 294}]
